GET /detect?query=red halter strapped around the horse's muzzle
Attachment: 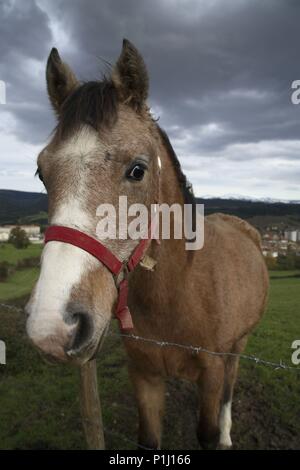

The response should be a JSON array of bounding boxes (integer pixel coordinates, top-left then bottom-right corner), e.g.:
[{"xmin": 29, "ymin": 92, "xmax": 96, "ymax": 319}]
[{"xmin": 45, "ymin": 225, "xmax": 156, "ymax": 331}]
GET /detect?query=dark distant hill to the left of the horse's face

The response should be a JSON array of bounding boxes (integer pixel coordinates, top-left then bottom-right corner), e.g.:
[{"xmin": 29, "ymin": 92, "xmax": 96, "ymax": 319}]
[{"xmin": 0, "ymin": 189, "xmax": 48, "ymax": 224}]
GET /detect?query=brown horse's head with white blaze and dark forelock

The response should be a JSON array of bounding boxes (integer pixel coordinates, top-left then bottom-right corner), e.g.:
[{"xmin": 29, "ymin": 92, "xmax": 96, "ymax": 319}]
[{"xmin": 26, "ymin": 40, "xmax": 159, "ymax": 362}]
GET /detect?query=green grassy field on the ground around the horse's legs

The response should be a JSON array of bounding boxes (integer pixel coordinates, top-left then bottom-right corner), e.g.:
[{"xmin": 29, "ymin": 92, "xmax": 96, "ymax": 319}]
[{"xmin": 0, "ymin": 255, "xmax": 300, "ymax": 449}]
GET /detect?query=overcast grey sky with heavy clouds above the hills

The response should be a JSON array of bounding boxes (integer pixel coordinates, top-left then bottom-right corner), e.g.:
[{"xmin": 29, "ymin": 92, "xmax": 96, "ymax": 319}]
[{"xmin": 0, "ymin": 0, "xmax": 300, "ymax": 199}]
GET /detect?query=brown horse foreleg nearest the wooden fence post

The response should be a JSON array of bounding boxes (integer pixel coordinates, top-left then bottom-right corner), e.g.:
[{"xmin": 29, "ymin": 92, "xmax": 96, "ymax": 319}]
[{"xmin": 130, "ymin": 368, "xmax": 165, "ymax": 449}]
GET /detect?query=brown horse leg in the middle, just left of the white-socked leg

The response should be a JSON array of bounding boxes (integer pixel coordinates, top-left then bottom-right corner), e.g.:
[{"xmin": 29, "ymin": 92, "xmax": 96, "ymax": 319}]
[{"xmin": 197, "ymin": 357, "xmax": 225, "ymax": 449}]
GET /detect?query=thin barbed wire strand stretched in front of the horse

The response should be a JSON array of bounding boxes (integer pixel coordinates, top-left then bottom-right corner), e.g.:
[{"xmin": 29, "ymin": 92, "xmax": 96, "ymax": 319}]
[{"xmin": 0, "ymin": 303, "xmax": 300, "ymax": 372}]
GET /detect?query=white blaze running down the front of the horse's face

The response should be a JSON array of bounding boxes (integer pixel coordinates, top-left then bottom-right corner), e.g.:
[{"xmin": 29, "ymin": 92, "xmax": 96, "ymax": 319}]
[{"xmin": 27, "ymin": 128, "xmax": 101, "ymax": 341}]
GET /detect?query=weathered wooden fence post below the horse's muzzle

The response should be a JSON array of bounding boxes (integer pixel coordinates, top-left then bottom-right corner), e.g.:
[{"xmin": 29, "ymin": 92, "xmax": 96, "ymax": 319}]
[{"xmin": 80, "ymin": 359, "xmax": 105, "ymax": 450}]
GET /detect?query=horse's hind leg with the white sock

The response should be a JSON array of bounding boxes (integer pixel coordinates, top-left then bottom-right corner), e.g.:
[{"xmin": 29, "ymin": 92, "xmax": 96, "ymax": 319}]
[{"xmin": 219, "ymin": 337, "xmax": 247, "ymax": 449}]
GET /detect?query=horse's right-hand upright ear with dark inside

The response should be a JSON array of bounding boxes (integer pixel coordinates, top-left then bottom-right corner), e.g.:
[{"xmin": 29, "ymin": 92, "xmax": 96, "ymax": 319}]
[{"xmin": 111, "ymin": 39, "xmax": 149, "ymax": 111}]
